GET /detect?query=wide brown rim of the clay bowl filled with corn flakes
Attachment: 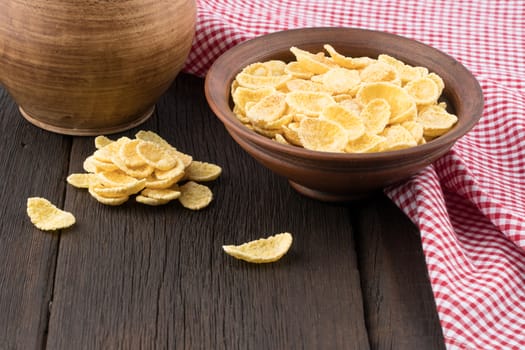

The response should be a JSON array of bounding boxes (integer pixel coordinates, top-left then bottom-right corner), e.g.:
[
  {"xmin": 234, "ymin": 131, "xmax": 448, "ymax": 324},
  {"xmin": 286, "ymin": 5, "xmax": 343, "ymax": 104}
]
[{"xmin": 204, "ymin": 27, "xmax": 483, "ymax": 162}]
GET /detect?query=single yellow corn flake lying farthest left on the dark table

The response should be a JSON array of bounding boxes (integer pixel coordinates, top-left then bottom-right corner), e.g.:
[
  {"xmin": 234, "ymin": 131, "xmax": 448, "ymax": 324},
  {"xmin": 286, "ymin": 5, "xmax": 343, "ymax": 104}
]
[{"xmin": 27, "ymin": 197, "xmax": 76, "ymax": 231}]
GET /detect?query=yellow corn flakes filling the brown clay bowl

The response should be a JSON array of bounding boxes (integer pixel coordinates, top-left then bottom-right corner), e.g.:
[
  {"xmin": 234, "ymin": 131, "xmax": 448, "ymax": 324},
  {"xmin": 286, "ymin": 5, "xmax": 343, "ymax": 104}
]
[{"xmin": 231, "ymin": 44, "xmax": 458, "ymax": 153}]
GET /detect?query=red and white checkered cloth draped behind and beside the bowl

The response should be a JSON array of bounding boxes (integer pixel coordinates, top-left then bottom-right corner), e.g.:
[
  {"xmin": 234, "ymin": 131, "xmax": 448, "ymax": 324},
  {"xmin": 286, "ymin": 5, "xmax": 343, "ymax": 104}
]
[{"xmin": 184, "ymin": 0, "xmax": 525, "ymax": 349}]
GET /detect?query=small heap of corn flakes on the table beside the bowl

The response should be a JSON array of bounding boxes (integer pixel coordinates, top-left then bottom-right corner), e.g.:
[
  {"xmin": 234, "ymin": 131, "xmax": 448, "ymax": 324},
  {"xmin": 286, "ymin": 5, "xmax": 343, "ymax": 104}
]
[{"xmin": 67, "ymin": 131, "xmax": 219, "ymax": 209}]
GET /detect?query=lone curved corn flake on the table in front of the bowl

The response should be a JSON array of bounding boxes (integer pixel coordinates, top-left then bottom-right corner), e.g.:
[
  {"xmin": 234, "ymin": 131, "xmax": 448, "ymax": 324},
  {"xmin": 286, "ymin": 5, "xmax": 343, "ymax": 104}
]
[{"xmin": 222, "ymin": 232, "xmax": 293, "ymax": 264}]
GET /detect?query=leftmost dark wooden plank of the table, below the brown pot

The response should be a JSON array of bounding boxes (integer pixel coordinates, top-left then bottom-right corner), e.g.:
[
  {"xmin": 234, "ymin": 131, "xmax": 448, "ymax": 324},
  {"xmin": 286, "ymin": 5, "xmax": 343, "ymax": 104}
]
[{"xmin": 0, "ymin": 88, "xmax": 71, "ymax": 349}]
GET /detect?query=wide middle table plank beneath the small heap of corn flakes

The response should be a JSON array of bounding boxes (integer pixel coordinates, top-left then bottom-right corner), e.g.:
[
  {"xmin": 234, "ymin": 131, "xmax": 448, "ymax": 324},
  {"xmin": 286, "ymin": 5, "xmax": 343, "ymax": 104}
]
[{"xmin": 47, "ymin": 75, "xmax": 368, "ymax": 349}]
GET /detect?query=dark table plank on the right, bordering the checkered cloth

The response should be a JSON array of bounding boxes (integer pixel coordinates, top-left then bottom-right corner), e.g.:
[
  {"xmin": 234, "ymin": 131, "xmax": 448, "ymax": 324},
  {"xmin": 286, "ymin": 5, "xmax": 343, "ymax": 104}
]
[{"xmin": 353, "ymin": 195, "xmax": 445, "ymax": 349}]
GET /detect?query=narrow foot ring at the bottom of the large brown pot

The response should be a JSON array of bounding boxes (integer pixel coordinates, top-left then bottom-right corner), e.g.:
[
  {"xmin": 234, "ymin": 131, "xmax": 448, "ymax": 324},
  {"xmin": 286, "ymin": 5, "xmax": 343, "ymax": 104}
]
[{"xmin": 18, "ymin": 105, "xmax": 155, "ymax": 136}]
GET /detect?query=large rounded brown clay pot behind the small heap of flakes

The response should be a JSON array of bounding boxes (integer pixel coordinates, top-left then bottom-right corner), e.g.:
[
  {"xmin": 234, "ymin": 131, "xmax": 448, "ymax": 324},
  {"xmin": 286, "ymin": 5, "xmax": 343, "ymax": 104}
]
[{"xmin": 0, "ymin": 0, "xmax": 196, "ymax": 135}]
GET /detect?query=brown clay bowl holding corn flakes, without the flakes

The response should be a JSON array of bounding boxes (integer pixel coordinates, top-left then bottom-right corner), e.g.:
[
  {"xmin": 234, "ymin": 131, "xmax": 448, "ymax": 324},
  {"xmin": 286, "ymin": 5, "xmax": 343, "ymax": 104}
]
[{"xmin": 205, "ymin": 28, "xmax": 483, "ymax": 201}]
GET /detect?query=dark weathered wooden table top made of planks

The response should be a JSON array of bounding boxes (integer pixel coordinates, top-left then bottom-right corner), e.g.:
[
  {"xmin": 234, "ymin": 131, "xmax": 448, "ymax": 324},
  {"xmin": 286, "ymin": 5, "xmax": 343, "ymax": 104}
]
[{"xmin": 0, "ymin": 74, "xmax": 444, "ymax": 349}]
